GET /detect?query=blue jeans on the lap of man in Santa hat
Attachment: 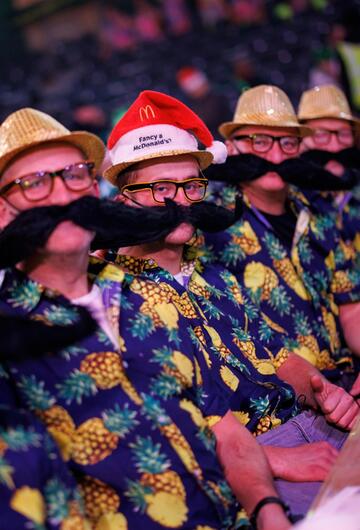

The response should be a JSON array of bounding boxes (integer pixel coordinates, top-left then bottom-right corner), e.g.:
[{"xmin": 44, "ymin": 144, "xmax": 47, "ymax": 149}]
[{"xmin": 257, "ymin": 411, "xmax": 348, "ymax": 516}]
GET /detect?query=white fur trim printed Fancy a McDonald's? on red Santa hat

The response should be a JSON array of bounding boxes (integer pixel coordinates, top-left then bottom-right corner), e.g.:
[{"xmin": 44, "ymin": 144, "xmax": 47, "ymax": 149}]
[{"xmin": 110, "ymin": 124, "xmax": 199, "ymax": 165}]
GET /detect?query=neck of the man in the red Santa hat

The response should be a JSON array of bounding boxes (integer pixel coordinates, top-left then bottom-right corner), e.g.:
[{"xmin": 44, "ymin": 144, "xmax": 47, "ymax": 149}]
[{"xmin": 119, "ymin": 242, "xmax": 184, "ymax": 275}]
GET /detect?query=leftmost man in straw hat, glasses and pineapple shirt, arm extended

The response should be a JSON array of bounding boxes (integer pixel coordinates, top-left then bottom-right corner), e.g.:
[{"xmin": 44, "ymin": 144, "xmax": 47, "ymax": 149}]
[{"xmin": 0, "ymin": 105, "xmax": 289, "ymax": 530}]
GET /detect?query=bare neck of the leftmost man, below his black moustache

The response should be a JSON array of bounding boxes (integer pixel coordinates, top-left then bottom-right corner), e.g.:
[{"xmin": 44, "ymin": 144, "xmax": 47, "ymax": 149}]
[{"xmin": 19, "ymin": 253, "xmax": 90, "ymax": 300}]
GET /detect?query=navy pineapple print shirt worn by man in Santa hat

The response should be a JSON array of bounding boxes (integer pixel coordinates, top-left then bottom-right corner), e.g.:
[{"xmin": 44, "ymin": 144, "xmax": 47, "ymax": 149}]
[{"xmin": 107, "ymin": 248, "xmax": 296, "ymax": 434}]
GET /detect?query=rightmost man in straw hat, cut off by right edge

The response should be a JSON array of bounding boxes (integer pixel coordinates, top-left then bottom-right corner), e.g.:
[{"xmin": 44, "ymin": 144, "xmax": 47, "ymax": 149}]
[{"xmin": 298, "ymin": 85, "xmax": 360, "ymax": 404}]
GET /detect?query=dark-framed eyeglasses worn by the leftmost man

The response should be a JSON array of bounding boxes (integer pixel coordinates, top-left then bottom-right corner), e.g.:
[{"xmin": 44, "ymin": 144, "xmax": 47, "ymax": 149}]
[{"xmin": 0, "ymin": 162, "xmax": 95, "ymax": 202}]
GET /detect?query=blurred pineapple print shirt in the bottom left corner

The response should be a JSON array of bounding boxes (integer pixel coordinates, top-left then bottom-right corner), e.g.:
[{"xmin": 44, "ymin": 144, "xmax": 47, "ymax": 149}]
[{"xmin": 0, "ymin": 405, "xmax": 89, "ymax": 530}]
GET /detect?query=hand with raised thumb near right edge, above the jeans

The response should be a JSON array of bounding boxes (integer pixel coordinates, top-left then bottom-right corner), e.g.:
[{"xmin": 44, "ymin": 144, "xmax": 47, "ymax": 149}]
[{"xmin": 310, "ymin": 375, "xmax": 360, "ymax": 430}]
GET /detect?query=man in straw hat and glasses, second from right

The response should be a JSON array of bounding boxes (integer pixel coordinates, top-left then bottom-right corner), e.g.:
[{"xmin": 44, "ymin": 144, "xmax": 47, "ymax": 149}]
[{"xmin": 202, "ymin": 85, "xmax": 360, "ymax": 392}]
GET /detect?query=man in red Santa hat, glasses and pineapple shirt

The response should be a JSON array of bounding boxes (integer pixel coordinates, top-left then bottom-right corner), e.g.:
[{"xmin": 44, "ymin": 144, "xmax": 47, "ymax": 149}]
[{"xmin": 100, "ymin": 91, "xmax": 358, "ymax": 513}]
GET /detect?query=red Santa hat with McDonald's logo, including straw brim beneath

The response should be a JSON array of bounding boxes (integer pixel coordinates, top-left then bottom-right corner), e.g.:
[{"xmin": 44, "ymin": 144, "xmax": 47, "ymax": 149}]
[{"xmin": 104, "ymin": 90, "xmax": 227, "ymax": 184}]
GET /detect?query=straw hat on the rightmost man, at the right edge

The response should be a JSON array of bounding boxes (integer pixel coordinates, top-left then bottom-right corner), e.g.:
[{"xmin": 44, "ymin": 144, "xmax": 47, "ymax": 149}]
[{"xmin": 298, "ymin": 85, "xmax": 360, "ymax": 129}]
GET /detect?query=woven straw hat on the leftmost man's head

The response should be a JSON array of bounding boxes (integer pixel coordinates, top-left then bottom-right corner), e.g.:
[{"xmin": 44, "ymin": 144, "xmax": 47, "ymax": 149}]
[{"xmin": 0, "ymin": 108, "xmax": 105, "ymax": 175}]
